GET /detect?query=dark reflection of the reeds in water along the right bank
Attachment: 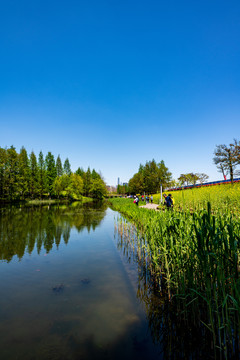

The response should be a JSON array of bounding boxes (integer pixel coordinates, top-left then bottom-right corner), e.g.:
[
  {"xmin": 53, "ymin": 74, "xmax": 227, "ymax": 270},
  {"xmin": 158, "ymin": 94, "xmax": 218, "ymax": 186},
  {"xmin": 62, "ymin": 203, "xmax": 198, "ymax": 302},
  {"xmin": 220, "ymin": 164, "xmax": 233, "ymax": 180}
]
[{"xmin": 115, "ymin": 216, "xmax": 227, "ymax": 360}]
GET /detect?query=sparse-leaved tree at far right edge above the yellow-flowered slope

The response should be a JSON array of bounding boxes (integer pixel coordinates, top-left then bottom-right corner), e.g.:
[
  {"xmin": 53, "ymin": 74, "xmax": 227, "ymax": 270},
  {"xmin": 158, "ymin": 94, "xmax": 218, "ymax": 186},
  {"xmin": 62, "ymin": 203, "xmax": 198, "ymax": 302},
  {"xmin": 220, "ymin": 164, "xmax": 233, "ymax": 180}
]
[{"xmin": 213, "ymin": 139, "xmax": 240, "ymax": 183}]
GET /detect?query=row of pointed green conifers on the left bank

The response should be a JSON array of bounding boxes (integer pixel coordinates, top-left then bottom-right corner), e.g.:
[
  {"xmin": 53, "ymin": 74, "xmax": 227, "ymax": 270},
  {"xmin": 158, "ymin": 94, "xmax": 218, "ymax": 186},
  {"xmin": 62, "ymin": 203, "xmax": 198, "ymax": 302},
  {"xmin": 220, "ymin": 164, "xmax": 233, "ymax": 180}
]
[{"xmin": 0, "ymin": 146, "xmax": 106, "ymax": 201}]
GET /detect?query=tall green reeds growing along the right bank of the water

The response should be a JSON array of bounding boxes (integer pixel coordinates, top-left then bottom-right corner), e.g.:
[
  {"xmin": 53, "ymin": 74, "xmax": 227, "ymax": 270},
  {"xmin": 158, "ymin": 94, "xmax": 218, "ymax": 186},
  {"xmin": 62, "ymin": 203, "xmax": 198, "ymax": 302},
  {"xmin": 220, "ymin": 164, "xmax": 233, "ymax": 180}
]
[{"xmin": 111, "ymin": 197, "xmax": 240, "ymax": 359}]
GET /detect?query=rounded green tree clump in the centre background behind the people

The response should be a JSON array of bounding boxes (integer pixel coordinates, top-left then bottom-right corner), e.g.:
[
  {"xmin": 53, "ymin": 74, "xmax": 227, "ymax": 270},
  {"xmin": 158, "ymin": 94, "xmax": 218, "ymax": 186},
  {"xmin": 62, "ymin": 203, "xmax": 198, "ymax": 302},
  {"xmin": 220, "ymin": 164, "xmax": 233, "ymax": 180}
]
[{"xmin": 128, "ymin": 159, "xmax": 172, "ymax": 194}]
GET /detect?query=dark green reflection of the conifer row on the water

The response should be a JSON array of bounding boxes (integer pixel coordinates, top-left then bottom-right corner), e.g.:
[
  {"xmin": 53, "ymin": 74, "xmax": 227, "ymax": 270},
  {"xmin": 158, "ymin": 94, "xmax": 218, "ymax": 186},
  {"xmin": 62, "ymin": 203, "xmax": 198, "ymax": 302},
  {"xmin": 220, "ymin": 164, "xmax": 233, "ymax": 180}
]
[{"xmin": 0, "ymin": 203, "xmax": 107, "ymax": 262}]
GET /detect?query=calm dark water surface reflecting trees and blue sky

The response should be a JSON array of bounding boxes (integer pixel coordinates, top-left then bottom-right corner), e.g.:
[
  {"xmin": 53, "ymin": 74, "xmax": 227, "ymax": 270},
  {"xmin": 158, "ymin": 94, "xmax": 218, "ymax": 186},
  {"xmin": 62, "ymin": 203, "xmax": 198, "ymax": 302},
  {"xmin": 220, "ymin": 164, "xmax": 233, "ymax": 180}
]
[{"xmin": 0, "ymin": 204, "xmax": 164, "ymax": 360}]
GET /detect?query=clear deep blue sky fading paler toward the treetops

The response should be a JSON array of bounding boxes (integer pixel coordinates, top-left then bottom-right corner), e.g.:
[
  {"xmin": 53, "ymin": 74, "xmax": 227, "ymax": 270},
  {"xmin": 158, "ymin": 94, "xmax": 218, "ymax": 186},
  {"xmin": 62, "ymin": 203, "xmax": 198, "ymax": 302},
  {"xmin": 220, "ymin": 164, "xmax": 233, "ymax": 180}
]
[{"xmin": 0, "ymin": 0, "xmax": 240, "ymax": 185}]
